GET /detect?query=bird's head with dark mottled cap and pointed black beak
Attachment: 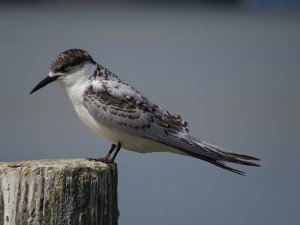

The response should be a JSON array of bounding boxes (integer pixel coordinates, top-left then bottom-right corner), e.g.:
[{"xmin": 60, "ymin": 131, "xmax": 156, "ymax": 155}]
[{"xmin": 30, "ymin": 49, "xmax": 96, "ymax": 94}]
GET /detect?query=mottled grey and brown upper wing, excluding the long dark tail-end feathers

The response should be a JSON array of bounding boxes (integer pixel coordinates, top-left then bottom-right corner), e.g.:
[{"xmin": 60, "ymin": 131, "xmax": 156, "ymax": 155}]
[{"xmin": 84, "ymin": 79, "xmax": 188, "ymax": 139}]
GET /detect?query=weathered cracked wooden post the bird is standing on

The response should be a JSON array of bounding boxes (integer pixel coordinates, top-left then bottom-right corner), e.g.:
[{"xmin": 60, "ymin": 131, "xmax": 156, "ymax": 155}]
[{"xmin": 0, "ymin": 159, "xmax": 119, "ymax": 225}]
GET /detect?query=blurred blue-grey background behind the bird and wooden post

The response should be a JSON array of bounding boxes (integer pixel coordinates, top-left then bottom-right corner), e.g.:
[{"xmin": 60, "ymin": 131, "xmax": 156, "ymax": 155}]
[{"xmin": 0, "ymin": 0, "xmax": 300, "ymax": 225}]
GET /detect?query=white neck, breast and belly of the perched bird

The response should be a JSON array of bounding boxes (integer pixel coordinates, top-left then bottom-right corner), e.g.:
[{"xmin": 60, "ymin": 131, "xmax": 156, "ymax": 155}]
[{"xmin": 58, "ymin": 64, "xmax": 182, "ymax": 154}]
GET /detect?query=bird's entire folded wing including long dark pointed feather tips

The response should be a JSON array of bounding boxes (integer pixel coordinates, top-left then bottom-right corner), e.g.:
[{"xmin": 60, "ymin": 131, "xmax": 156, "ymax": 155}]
[{"xmin": 83, "ymin": 67, "xmax": 259, "ymax": 175}]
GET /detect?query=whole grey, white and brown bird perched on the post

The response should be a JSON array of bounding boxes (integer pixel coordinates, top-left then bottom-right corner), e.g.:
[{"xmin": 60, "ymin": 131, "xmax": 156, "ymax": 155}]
[{"xmin": 30, "ymin": 48, "xmax": 260, "ymax": 175}]
